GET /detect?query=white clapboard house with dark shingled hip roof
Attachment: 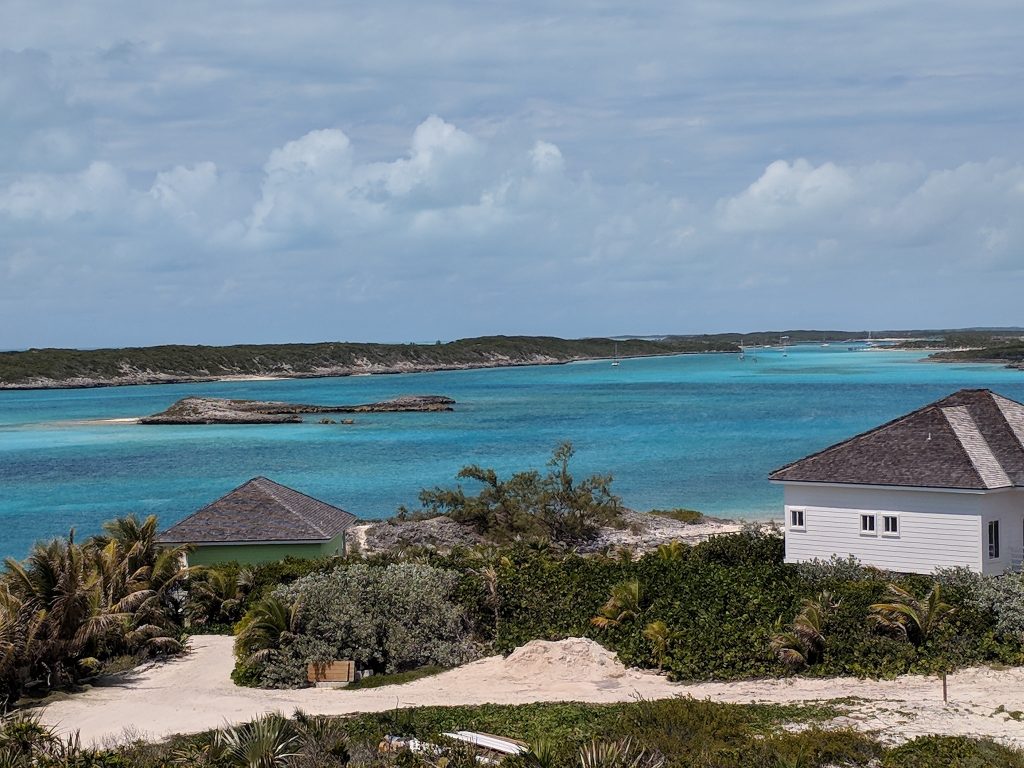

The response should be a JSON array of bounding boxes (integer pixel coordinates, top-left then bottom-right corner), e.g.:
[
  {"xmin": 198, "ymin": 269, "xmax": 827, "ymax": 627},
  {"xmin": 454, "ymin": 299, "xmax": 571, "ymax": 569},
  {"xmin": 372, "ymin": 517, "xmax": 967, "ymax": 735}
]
[{"xmin": 769, "ymin": 389, "xmax": 1024, "ymax": 573}]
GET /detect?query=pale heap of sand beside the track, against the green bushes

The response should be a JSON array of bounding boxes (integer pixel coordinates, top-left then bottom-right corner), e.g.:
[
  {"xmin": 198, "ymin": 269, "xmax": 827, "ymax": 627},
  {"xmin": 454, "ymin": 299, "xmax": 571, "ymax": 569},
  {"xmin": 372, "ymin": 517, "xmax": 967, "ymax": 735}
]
[{"xmin": 505, "ymin": 637, "xmax": 626, "ymax": 680}]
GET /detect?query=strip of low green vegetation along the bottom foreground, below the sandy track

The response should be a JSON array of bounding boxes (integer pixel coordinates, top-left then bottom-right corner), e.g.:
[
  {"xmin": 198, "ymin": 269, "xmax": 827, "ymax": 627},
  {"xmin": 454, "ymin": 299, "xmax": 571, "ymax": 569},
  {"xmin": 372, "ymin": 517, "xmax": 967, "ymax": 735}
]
[{"xmin": 8, "ymin": 699, "xmax": 1024, "ymax": 768}]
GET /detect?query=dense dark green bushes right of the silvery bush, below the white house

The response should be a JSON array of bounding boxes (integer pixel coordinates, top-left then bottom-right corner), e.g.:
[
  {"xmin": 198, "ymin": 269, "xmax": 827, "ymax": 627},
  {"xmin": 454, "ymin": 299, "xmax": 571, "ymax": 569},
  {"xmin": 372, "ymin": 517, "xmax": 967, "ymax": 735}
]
[{"xmin": 485, "ymin": 530, "xmax": 1024, "ymax": 679}]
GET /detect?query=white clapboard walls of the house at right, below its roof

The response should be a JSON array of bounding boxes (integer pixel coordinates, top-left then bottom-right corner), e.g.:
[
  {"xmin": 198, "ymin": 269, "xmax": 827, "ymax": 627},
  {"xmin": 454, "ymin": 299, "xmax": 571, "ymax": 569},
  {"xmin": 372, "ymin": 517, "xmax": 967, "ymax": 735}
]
[{"xmin": 783, "ymin": 483, "xmax": 991, "ymax": 573}]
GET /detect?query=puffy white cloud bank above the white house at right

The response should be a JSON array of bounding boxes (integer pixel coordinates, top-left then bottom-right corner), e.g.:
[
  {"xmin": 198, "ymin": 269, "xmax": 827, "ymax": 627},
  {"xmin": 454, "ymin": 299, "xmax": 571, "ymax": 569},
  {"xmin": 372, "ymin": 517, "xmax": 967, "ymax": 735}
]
[{"xmin": 716, "ymin": 154, "xmax": 1024, "ymax": 270}]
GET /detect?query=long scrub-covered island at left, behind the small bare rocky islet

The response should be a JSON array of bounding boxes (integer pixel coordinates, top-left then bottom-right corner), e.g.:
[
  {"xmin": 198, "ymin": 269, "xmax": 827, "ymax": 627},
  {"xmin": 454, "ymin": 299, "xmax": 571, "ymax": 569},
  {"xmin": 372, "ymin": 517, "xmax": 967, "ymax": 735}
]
[{"xmin": 0, "ymin": 336, "xmax": 739, "ymax": 389}]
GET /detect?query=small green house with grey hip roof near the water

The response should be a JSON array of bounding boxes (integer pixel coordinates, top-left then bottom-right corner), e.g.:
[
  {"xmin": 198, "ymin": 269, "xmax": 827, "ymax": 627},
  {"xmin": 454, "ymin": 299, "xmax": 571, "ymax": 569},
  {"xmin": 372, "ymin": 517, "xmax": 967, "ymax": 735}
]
[{"xmin": 159, "ymin": 477, "xmax": 355, "ymax": 565}]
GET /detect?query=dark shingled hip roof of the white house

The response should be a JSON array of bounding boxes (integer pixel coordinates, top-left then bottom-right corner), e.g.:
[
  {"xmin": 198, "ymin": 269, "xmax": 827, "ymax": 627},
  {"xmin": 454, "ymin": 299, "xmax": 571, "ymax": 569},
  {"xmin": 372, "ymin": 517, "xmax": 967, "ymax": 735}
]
[{"xmin": 769, "ymin": 389, "xmax": 1024, "ymax": 490}]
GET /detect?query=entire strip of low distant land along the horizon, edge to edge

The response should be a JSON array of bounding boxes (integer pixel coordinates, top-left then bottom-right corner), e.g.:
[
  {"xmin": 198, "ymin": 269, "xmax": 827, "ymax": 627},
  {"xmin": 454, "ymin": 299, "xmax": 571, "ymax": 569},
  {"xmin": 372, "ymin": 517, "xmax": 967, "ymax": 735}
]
[{"xmin": 0, "ymin": 328, "xmax": 1024, "ymax": 389}]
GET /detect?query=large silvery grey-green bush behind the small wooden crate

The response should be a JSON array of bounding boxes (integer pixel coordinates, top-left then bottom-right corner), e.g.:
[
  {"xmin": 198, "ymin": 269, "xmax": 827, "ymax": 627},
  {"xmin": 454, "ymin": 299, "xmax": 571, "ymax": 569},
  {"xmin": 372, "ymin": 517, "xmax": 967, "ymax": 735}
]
[{"xmin": 237, "ymin": 563, "xmax": 478, "ymax": 687}]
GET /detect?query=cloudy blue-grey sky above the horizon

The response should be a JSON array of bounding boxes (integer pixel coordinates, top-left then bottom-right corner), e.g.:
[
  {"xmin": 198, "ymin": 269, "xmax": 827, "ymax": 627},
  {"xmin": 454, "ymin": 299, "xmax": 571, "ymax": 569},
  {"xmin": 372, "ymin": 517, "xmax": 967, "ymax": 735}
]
[{"xmin": 0, "ymin": 0, "xmax": 1024, "ymax": 349}]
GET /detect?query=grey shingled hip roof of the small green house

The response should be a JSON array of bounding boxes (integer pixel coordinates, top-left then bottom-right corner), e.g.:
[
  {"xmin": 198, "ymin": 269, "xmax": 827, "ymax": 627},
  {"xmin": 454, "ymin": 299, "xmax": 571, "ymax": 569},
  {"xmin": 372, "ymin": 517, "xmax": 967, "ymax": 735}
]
[{"xmin": 154, "ymin": 477, "xmax": 356, "ymax": 544}]
